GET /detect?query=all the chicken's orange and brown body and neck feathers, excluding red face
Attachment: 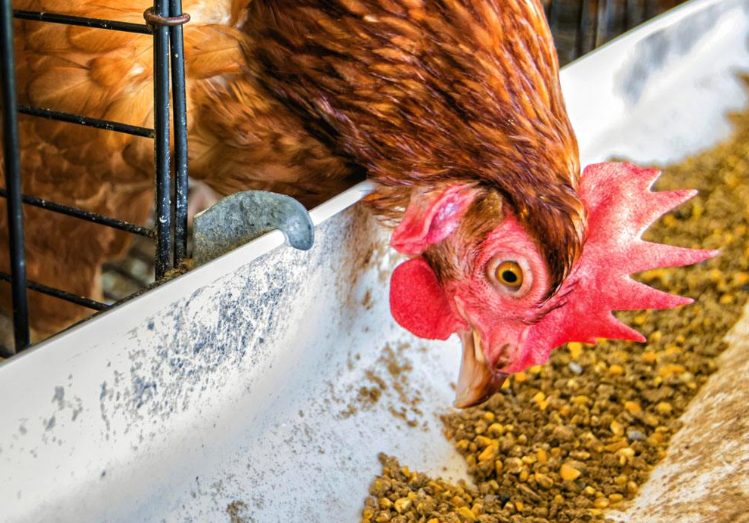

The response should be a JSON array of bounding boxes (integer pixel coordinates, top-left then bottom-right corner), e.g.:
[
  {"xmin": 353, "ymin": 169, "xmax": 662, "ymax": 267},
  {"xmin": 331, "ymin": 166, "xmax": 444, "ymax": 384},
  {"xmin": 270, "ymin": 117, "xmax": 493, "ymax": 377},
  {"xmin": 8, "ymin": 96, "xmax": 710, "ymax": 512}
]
[{"xmin": 0, "ymin": 0, "xmax": 585, "ymax": 364}]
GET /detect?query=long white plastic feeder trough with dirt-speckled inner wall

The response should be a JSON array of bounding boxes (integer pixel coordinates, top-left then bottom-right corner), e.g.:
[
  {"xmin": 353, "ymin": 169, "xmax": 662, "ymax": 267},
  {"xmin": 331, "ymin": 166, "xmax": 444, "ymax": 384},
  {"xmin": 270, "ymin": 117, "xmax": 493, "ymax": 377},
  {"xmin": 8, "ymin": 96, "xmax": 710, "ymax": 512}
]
[{"xmin": 0, "ymin": 0, "xmax": 749, "ymax": 523}]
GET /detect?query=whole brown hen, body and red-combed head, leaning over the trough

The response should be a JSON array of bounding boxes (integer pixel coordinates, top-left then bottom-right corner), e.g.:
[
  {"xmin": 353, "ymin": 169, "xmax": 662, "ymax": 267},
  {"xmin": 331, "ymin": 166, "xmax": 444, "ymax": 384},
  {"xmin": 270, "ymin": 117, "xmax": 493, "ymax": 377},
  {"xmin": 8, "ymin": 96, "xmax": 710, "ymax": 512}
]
[{"xmin": 0, "ymin": 0, "xmax": 714, "ymax": 406}]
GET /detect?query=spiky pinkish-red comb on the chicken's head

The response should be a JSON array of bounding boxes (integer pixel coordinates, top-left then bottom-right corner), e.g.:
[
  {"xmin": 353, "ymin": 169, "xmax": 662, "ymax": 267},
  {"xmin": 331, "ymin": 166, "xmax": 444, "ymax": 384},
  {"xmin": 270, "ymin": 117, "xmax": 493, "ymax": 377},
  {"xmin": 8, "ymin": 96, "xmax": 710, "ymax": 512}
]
[{"xmin": 503, "ymin": 163, "xmax": 718, "ymax": 372}]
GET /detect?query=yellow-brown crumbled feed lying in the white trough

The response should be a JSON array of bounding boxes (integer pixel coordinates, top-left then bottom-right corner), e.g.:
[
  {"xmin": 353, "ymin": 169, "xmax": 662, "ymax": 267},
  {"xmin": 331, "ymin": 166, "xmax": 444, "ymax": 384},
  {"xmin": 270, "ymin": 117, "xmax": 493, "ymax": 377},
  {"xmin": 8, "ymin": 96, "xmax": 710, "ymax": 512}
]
[{"xmin": 362, "ymin": 85, "xmax": 749, "ymax": 523}]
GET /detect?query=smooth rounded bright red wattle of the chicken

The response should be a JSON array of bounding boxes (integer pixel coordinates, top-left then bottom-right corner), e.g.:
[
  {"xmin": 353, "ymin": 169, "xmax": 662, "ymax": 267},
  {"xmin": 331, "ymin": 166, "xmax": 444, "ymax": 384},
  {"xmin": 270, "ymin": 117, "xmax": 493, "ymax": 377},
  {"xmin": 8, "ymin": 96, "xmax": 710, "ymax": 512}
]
[{"xmin": 390, "ymin": 257, "xmax": 461, "ymax": 340}]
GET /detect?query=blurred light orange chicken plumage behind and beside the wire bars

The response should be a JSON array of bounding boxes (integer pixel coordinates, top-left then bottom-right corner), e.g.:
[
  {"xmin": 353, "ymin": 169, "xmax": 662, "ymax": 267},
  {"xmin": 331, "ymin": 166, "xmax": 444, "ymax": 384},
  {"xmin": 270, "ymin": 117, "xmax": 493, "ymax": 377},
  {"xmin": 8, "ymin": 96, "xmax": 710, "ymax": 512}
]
[{"xmin": 0, "ymin": 0, "xmax": 351, "ymax": 340}]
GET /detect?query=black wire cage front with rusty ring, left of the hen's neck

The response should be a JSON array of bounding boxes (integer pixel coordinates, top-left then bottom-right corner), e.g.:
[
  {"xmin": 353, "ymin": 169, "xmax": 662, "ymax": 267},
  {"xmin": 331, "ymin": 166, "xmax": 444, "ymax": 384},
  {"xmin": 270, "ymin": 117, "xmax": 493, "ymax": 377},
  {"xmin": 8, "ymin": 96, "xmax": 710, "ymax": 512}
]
[{"xmin": 0, "ymin": 0, "xmax": 190, "ymax": 355}]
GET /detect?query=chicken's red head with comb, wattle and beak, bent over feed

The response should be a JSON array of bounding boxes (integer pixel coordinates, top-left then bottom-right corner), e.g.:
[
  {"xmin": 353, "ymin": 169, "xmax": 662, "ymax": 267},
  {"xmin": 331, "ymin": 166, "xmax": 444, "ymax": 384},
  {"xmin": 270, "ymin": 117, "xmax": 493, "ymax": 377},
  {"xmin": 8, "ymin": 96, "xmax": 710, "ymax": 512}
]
[{"xmin": 390, "ymin": 163, "xmax": 717, "ymax": 408}]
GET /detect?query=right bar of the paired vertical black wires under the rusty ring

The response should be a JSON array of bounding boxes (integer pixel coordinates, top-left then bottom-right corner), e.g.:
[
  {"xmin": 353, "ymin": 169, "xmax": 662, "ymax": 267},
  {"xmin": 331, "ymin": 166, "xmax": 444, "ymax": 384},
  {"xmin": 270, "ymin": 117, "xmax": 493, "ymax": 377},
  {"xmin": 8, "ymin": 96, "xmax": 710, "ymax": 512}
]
[{"xmin": 169, "ymin": 0, "xmax": 187, "ymax": 267}]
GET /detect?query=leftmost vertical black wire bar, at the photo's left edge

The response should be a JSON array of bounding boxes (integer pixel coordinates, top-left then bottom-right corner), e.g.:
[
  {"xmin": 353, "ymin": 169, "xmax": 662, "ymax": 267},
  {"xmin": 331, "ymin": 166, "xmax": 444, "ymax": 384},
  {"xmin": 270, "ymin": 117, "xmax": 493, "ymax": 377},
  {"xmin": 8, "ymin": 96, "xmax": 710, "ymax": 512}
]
[{"xmin": 0, "ymin": 0, "xmax": 29, "ymax": 352}]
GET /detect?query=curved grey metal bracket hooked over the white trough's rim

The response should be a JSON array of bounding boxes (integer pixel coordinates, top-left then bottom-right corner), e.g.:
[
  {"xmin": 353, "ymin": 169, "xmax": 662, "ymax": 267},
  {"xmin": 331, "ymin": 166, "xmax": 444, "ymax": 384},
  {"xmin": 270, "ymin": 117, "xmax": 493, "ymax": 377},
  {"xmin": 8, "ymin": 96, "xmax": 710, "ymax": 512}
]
[{"xmin": 193, "ymin": 191, "xmax": 315, "ymax": 266}]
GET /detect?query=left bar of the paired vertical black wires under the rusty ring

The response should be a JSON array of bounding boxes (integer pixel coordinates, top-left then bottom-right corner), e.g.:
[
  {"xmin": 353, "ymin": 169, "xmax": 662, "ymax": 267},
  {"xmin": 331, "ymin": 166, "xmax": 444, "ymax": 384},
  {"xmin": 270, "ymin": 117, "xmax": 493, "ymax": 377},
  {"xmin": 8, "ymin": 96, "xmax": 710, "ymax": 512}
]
[{"xmin": 153, "ymin": 0, "xmax": 172, "ymax": 280}]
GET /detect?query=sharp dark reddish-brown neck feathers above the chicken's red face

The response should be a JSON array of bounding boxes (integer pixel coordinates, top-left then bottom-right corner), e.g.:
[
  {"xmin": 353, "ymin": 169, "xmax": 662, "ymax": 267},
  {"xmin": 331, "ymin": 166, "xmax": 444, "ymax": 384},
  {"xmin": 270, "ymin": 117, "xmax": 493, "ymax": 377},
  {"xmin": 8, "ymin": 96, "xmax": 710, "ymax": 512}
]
[{"xmin": 245, "ymin": 0, "xmax": 584, "ymax": 286}]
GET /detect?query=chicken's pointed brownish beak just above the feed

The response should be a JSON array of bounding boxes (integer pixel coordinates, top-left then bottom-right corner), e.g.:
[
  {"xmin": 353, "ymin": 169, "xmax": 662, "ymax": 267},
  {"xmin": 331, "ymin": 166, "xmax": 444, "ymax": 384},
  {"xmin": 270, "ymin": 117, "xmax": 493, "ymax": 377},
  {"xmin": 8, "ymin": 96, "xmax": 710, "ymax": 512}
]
[{"xmin": 454, "ymin": 330, "xmax": 508, "ymax": 409}]
